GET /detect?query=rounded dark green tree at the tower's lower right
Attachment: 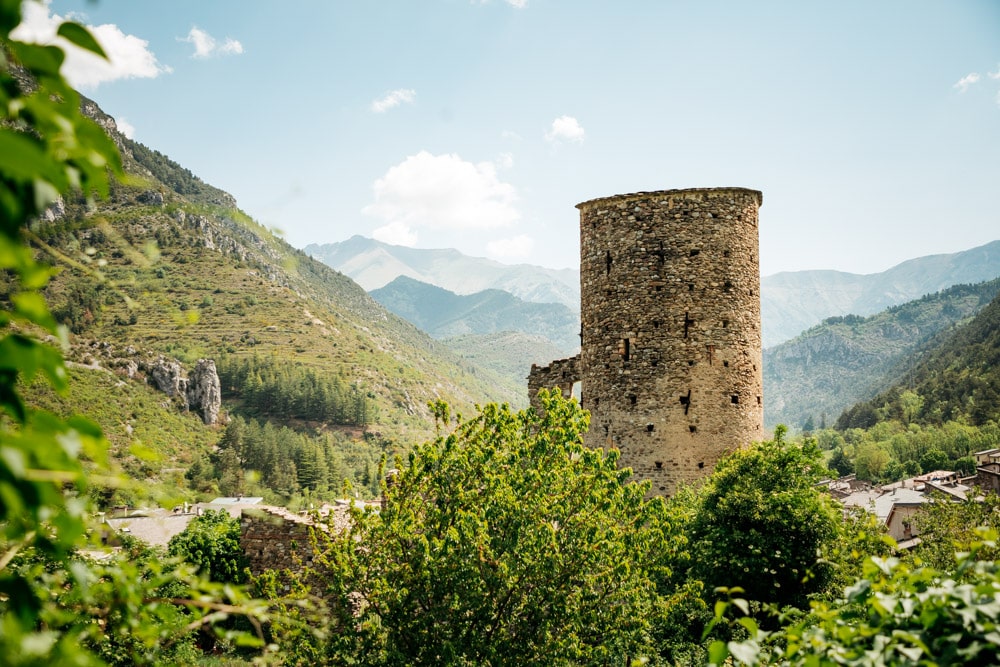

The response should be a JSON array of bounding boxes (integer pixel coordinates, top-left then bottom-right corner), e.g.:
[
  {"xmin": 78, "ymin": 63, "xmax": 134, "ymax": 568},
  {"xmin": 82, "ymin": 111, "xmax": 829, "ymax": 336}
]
[{"xmin": 686, "ymin": 426, "xmax": 842, "ymax": 608}]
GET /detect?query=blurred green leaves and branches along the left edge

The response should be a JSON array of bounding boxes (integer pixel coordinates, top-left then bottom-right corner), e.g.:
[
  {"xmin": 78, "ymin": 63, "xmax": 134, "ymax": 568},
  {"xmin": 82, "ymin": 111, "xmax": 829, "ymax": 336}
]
[{"xmin": 0, "ymin": 0, "xmax": 274, "ymax": 665}]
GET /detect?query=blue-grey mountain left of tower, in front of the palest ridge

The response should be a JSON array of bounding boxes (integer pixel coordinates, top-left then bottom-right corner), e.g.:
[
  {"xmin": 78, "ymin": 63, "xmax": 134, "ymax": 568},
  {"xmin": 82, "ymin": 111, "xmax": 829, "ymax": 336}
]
[{"xmin": 370, "ymin": 276, "xmax": 580, "ymax": 353}]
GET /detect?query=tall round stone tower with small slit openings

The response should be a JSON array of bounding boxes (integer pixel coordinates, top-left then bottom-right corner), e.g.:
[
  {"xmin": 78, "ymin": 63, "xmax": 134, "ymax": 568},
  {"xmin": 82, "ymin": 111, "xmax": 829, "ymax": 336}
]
[{"xmin": 572, "ymin": 188, "xmax": 764, "ymax": 495}]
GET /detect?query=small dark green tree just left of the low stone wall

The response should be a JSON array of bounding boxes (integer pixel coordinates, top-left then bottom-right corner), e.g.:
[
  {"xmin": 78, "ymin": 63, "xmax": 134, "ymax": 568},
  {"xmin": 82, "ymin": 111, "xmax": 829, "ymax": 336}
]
[{"xmin": 167, "ymin": 510, "xmax": 249, "ymax": 584}]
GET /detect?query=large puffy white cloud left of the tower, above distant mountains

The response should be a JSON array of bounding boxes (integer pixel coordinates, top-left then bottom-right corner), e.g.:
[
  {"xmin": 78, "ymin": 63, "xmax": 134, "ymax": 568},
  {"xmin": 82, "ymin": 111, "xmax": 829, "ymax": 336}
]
[{"xmin": 362, "ymin": 151, "xmax": 521, "ymax": 245}]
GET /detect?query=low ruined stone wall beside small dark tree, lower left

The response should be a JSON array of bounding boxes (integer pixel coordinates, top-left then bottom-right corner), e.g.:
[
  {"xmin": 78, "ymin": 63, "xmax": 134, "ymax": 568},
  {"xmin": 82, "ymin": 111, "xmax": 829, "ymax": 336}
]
[{"xmin": 240, "ymin": 507, "xmax": 327, "ymax": 575}]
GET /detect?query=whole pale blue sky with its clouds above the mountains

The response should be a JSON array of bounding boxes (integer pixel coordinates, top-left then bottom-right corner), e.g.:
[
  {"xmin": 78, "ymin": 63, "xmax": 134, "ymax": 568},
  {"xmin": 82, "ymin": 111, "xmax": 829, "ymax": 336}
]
[{"xmin": 17, "ymin": 0, "xmax": 1000, "ymax": 275}]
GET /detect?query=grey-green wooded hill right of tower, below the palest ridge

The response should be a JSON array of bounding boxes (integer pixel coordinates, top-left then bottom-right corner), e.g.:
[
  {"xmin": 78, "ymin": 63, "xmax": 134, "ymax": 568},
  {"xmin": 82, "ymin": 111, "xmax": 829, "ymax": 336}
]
[{"xmin": 764, "ymin": 279, "xmax": 1000, "ymax": 427}]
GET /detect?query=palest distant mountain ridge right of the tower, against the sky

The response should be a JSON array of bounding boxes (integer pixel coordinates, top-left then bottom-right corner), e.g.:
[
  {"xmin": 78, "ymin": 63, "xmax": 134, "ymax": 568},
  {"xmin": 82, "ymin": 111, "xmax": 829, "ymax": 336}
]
[{"xmin": 761, "ymin": 241, "xmax": 1000, "ymax": 348}]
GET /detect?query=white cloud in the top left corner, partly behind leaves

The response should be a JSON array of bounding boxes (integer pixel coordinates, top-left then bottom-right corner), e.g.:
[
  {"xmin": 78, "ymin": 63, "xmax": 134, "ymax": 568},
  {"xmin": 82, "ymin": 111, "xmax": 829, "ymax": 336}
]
[{"xmin": 11, "ymin": 0, "xmax": 171, "ymax": 88}]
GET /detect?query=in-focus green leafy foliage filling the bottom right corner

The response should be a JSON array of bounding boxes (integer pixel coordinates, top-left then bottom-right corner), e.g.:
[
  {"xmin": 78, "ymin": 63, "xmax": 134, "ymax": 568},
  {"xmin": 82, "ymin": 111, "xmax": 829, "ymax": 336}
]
[{"xmin": 709, "ymin": 530, "xmax": 1000, "ymax": 667}]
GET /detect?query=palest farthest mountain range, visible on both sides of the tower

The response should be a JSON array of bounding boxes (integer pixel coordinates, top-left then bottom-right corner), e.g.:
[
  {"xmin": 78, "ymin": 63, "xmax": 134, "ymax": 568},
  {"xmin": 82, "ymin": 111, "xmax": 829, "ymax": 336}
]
[{"xmin": 304, "ymin": 236, "xmax": 1000, "ymax": 348}]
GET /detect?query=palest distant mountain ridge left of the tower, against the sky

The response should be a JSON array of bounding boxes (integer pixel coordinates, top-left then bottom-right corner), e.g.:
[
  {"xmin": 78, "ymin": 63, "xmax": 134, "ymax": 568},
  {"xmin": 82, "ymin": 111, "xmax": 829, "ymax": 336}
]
[{"xmin": 303, "ymin": 236, "xmax": 580, "ymax": 312}]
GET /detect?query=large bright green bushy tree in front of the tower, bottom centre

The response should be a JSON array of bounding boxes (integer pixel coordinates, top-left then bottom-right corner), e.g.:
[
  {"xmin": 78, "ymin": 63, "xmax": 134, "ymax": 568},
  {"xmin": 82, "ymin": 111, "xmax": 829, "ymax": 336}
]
[{"xmin": 308, "ymin": 392, "xmax": 671, "ymax": 665}]
